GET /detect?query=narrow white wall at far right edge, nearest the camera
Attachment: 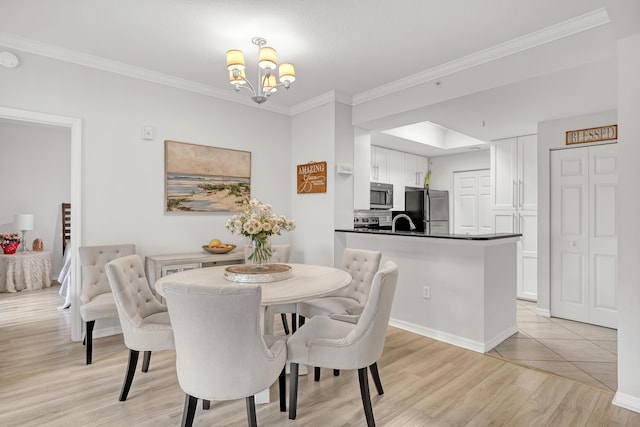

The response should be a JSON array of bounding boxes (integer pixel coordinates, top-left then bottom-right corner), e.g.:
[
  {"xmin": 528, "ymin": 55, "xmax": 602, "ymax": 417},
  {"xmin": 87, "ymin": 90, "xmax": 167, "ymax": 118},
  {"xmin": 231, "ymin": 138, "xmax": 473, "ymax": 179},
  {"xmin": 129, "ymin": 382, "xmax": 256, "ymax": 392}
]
[{"xmin": 613, "ymin": 33, "xmax": 640, "ymax": 412}]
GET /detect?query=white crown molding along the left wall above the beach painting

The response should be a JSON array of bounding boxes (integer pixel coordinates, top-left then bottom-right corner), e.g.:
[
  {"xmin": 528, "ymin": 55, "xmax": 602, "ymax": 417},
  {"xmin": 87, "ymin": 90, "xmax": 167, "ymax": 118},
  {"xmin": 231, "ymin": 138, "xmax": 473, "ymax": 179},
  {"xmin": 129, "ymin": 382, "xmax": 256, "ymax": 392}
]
[{"xmin": 0, "ymin": 32, "xmax": 291, "ymax": 115}]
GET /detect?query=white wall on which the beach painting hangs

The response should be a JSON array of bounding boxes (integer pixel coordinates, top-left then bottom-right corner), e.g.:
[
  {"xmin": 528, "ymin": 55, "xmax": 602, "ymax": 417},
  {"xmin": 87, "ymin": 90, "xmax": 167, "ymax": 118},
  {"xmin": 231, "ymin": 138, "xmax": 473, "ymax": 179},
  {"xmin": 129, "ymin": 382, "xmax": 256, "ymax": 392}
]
[{"xmin": 0, "ymin": 53, "xmax": 290, "ymax": 262}]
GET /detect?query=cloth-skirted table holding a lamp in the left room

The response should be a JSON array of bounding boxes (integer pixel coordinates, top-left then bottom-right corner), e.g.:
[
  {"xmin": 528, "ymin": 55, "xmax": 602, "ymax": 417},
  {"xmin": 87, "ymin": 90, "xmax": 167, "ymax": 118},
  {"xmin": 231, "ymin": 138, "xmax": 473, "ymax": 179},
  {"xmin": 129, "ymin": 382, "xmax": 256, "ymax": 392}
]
[{"xmin": 0, "ymin": 251, "xmax": 51, "ymax": 292}]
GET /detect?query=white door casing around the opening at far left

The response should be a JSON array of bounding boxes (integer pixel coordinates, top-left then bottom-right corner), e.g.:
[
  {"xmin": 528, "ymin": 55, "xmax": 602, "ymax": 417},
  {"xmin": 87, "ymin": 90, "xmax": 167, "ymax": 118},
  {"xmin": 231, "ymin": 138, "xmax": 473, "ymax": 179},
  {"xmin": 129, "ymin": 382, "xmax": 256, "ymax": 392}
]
[{"xmin": 0, "ymin": 107, "xmax": 82, "ymax": 341}]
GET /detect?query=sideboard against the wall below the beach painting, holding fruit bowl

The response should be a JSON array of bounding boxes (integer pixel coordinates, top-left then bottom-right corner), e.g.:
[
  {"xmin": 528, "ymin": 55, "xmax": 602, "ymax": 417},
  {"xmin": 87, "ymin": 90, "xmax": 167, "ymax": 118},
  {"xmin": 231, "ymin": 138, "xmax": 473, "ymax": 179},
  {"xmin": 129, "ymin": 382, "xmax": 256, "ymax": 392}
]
[{"xmin": 145, "ymin": 248, "xmax": 244, "ymax": 288}]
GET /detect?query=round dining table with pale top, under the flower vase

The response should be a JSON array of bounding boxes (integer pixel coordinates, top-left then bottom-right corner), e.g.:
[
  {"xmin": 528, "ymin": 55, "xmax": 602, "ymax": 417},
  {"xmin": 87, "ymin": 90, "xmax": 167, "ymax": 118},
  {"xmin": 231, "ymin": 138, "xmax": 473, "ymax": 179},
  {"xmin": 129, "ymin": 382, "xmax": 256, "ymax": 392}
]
[{"xmin": 155, "ymin": 263, "xmax": 352, "ymax": 403}]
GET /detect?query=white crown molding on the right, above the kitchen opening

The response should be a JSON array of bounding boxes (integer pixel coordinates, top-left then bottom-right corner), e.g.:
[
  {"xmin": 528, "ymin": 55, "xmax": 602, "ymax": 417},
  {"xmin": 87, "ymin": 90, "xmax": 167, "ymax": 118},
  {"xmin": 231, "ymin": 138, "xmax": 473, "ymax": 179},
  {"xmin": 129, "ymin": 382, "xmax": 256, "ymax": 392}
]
[{"xmin": 353, "ymin": 8, "xmax": 610, "ymax": 105}]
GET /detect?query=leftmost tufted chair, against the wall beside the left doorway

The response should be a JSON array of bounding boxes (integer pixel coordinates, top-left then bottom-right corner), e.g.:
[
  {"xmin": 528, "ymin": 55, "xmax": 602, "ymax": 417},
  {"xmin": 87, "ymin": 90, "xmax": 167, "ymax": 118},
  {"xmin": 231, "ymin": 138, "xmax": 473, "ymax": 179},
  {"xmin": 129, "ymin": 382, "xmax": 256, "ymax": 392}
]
[{"xmin": 78, "ymin": 244, "xmax": 136, "ymax": 365}]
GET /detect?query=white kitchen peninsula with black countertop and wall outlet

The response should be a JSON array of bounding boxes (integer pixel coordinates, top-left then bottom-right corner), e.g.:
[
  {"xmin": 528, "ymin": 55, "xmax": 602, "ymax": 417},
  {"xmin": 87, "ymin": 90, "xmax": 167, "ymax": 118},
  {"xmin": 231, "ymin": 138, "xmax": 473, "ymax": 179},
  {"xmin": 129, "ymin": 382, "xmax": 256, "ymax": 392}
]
[{"xmin": 335, "ymin": 229, "xmax": 521, "ymax": 353}]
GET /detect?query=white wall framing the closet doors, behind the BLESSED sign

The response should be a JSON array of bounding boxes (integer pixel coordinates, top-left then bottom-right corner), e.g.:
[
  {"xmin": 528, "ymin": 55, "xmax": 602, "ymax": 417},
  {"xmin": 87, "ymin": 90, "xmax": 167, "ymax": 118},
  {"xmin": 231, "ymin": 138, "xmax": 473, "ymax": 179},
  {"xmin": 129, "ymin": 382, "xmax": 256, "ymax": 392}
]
[{"xmin": 538, "ymin": 111, "xmax": 618, "ymax": 314}]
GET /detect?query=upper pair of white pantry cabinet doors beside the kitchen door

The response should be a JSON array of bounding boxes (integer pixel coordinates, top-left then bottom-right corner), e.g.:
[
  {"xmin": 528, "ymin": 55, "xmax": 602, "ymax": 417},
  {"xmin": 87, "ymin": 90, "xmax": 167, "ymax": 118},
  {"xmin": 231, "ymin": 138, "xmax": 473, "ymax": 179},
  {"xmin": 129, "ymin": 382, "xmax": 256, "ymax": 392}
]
[{"xmin": 491, "ymin": 135, "xmax": 538, "ymax": 210}]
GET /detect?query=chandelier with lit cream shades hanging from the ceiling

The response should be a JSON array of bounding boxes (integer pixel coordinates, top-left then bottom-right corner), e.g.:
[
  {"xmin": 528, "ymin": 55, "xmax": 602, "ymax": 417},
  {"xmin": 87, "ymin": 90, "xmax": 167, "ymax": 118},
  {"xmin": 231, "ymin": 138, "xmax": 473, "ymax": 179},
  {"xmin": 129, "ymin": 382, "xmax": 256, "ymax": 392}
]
[{"xmin": 227, "ymin": 37, "xmax": 296, "ymax": 104}]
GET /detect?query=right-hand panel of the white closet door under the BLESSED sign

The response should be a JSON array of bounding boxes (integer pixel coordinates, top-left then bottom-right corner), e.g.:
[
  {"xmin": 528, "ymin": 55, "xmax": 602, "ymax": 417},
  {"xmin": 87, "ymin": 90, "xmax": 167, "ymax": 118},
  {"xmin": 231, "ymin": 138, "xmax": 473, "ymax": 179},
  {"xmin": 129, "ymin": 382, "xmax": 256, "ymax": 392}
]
[{"xmin": 589, "ymin": 144, "xmax": 618, "ymax": 328}]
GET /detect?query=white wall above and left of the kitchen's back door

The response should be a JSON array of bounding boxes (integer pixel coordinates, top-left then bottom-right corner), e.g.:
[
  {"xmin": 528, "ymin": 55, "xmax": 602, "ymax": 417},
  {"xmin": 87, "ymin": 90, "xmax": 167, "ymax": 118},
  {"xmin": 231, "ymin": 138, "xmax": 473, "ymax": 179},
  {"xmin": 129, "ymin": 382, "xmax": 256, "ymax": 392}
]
[{"xmin": 429, "ymin": 150, "xmax": 491, "ymax": 233}]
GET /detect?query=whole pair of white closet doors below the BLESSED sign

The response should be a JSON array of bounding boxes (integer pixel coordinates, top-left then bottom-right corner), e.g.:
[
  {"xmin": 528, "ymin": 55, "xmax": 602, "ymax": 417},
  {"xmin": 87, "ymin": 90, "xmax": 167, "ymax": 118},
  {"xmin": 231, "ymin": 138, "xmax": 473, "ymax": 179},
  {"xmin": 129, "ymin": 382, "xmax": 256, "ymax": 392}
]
[{"xmin": 551, "ymin": 144, "xmax": 617, "ymax": 328}]
